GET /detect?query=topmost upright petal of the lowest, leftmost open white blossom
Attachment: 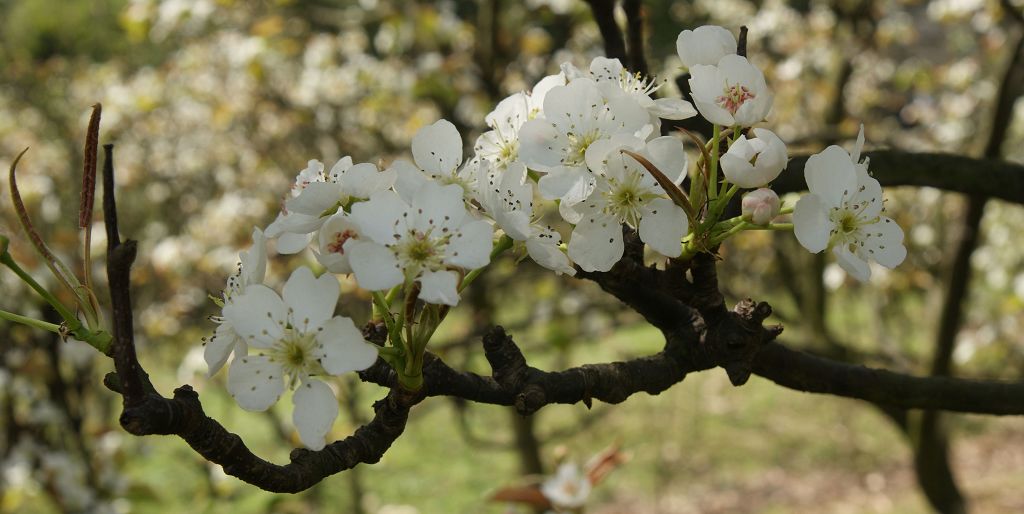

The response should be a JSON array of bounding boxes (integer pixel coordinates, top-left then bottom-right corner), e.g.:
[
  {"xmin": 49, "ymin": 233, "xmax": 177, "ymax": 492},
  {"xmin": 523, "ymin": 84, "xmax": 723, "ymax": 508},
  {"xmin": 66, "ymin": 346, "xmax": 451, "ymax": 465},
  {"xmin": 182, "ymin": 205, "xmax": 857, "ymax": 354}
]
[{"xmin": 284, "ymin": 266, "xmax": 341, "ymax": 333}]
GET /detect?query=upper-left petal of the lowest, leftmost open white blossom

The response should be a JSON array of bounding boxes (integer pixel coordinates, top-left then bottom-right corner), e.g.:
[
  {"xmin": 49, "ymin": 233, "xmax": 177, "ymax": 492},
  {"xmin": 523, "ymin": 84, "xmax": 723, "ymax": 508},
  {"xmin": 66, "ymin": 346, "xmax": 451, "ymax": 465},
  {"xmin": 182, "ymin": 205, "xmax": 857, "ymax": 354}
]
[{"xmin": 224, "ymin": 284, "xmax": 288, "ymax": 348}]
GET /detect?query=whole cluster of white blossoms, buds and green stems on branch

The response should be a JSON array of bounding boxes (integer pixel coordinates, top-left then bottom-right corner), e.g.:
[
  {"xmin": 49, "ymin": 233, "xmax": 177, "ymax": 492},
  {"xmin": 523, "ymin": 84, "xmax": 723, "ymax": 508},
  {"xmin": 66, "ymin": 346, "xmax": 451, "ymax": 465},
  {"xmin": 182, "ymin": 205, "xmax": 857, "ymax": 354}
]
[{"xmin": 206, "ymin": 26, "xmax": 905, "ymax": 448}]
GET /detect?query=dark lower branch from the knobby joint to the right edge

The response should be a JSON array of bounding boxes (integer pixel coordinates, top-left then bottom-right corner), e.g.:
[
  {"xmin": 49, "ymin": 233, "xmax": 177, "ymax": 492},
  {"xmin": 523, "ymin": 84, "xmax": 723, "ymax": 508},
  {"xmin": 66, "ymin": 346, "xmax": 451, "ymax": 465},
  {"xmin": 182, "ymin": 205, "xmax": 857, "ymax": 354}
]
[{"xmin": 754, "ymin": 343, "xmax": 1024, "ymax": 415}]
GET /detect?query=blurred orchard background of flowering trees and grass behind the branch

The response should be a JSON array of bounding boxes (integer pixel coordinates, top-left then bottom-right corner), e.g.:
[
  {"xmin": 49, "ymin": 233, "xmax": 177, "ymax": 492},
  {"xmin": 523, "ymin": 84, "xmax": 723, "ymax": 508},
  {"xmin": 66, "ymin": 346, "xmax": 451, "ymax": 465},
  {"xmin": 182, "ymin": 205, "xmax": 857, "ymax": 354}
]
[{"xmin": 0, "ymin": 0, "xmax": 1024, "ymax": 514}]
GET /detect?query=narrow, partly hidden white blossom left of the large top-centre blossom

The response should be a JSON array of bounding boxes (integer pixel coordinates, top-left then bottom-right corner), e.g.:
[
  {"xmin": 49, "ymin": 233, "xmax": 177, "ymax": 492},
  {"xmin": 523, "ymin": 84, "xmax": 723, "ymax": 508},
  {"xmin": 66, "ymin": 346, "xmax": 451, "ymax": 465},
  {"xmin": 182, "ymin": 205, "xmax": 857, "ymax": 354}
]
[{"xmin": 474, "ymin": 74, "xmax": 565, "ymax": 169}]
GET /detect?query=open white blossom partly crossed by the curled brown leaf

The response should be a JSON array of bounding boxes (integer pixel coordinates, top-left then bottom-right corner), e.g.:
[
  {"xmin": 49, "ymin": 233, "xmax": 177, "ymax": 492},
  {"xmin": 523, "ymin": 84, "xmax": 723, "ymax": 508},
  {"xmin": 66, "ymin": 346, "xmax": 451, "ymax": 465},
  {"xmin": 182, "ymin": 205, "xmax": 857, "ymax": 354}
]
[{"xmin": 568, "ymin": 136, "xmax": 689, "ymax": 271}]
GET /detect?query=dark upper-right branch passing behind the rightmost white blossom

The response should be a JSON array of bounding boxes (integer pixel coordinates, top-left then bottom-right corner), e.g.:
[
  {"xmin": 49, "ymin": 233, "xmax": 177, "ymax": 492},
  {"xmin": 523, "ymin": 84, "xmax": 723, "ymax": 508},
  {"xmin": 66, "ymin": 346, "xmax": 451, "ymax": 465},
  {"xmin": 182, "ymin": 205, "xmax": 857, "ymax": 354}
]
[{"xmin": 772, "ymin": 151, "xmax": 1024, "ymax": 204}]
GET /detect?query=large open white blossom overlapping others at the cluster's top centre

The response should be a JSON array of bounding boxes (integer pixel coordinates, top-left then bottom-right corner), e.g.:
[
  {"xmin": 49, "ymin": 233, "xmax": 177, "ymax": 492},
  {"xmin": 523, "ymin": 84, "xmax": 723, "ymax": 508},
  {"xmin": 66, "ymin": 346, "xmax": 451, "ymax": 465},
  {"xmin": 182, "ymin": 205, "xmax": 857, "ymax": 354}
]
[{"xmin": 519, "ymin": 78, "xmax": 651, "ymax": 212}]
